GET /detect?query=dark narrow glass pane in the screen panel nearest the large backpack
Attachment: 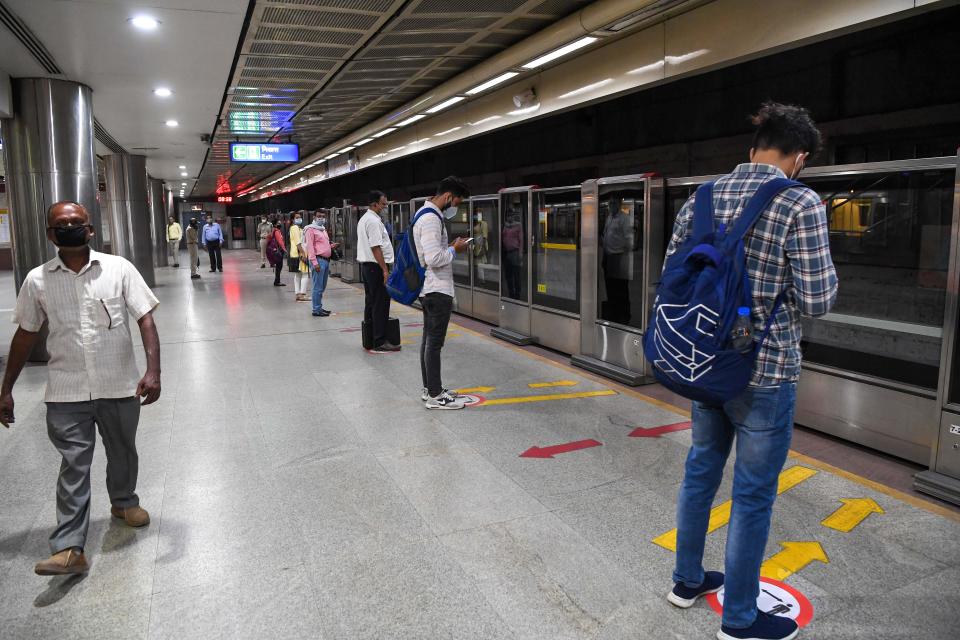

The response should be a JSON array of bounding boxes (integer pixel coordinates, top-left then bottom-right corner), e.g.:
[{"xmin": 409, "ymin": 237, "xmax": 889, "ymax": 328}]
[{"xmin": 597, "ymin": 185, "xmax": 647, "ymax": 329}]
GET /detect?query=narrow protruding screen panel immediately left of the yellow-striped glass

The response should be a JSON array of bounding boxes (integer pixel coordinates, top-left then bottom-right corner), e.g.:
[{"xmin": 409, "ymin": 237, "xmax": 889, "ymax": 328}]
[{"xmin": 490, "ymin": 187, "xmax": 533, "ymax": 345}]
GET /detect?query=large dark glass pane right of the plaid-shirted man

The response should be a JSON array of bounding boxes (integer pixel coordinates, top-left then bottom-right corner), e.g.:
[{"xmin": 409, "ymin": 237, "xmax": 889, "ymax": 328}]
[{"xmin": 802, "ymin": 170, "xmax": 955, "ymax": 389}]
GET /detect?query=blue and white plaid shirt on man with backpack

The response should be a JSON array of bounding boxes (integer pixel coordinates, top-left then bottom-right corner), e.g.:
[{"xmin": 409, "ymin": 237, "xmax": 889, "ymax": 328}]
[{"xmin": 667, "ymin": 164, "xmax": 837, "ymax": 387}]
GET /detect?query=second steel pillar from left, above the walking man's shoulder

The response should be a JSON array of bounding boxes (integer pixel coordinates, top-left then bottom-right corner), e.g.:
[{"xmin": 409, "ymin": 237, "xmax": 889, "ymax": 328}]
[{"xmin": 105, "ymin": 153, "xmax": 156, "ymax": 287}]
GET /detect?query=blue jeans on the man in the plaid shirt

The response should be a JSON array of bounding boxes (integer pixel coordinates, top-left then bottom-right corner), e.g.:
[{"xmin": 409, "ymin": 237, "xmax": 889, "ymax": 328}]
[{"xmin": 673, "ymin": 383, "xmax": 797, "ymax": 629}]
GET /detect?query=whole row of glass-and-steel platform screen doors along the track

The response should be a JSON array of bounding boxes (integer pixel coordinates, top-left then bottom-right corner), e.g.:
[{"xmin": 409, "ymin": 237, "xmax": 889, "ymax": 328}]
[{"xmin": 316, "ymin": 156, "xmax": 960, "ymax": 476}]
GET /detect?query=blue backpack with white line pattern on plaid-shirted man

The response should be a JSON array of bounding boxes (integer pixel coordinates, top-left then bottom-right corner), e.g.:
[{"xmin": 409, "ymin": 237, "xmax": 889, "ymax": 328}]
[{"xmin": 643, "ymin": 178, "xmax": 800, "ymax": 405}]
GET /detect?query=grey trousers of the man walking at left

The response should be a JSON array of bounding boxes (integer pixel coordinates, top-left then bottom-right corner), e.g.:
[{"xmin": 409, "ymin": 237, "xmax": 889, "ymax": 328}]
[{"xmin": 47, "ymin": 397, "xmax": 140, "ymax": 553}]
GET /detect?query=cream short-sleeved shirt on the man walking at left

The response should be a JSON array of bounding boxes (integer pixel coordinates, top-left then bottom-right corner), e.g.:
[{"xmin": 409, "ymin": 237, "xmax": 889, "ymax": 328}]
[{"xmin": 13, "ymin": 250, "xmax": 158, "ymax": 402}]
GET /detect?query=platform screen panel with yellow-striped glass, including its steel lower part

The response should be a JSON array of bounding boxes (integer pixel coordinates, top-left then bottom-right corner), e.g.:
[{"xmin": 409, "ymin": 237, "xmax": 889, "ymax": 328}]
[{"xmin": 530, "ymin": 185, "xmax": 581, "ymax": 354}]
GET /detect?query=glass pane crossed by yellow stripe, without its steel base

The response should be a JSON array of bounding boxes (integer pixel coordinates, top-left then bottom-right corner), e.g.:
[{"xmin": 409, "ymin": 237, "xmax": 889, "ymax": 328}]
[{"xmin": 532, "ymin": 189, "xmax": 580, "ymax": 313}]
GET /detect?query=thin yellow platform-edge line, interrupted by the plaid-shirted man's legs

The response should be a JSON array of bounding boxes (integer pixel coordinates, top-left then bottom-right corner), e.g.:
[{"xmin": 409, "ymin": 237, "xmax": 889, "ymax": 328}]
[{"xmin": 453, "ymin": 323, "xmax": 960, "ymax": 522}]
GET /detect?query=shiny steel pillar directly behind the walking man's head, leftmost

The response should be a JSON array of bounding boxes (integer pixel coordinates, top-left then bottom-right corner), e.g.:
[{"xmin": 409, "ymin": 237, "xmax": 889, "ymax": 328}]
[{"xmin": 0, "ymin": 78, "xmax": 102, "ymax": 292}]
